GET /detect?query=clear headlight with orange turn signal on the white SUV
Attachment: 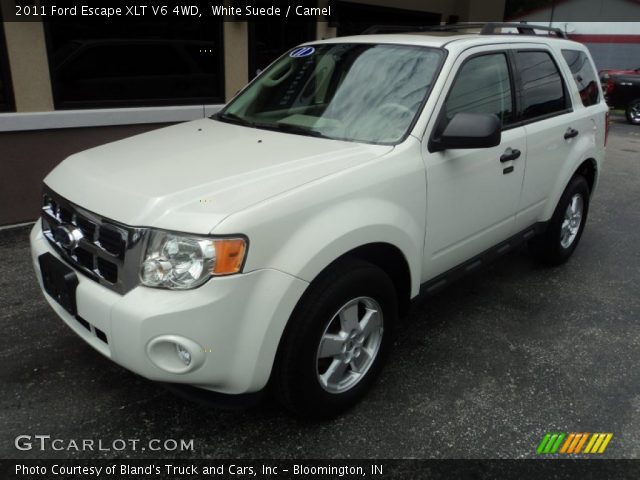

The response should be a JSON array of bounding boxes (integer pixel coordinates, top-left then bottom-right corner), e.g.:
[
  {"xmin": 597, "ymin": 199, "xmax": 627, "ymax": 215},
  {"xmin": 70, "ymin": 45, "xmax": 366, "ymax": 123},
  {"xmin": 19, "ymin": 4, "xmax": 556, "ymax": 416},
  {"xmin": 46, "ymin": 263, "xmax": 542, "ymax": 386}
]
[{"xmin": 140, "ymin": 230, "xmax": 247, "ymax": 290}]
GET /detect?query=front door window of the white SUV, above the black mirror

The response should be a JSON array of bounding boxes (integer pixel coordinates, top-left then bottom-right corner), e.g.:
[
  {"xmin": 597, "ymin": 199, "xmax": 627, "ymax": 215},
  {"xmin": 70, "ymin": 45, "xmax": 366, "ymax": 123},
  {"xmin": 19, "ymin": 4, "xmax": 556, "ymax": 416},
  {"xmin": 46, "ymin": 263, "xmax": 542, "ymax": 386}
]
[{"xmin": 444, "ymin": 53, "xmax": 514, "ymax": 126}]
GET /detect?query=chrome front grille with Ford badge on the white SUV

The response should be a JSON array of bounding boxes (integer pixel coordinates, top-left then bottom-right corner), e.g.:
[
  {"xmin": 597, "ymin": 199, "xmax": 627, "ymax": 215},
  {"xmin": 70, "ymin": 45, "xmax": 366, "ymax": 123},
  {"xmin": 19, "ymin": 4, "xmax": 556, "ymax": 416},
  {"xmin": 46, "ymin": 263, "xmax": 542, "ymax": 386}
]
[{"xmin": 42, "ymin": 187, "xmax": 147, "ymax": 294}]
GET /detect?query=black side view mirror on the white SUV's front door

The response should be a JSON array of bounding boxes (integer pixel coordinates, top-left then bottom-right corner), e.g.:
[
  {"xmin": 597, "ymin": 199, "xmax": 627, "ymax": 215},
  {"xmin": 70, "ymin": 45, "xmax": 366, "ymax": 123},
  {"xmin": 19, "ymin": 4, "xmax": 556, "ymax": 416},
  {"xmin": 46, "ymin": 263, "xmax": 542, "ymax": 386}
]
[{"xmin": 429, "ymin": 113, "xmax": 502, "ymax": 152}]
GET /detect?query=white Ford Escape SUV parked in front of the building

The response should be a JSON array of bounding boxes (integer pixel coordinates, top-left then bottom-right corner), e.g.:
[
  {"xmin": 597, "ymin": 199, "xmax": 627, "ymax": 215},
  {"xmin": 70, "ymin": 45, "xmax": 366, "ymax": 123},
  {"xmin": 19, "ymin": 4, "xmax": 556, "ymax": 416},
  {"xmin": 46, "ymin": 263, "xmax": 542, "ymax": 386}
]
[{"xmin": 31, "ymin": 25, "xmax": 607, "ymax": 417}]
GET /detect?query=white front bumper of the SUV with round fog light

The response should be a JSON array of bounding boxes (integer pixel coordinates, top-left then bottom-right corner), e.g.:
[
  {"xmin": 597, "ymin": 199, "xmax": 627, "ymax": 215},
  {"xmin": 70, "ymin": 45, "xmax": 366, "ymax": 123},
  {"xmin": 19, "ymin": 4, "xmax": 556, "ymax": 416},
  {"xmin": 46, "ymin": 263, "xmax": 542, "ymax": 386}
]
[{"xmin": 30, "ymin": 222, "xmax": 308, "ymax": 394}]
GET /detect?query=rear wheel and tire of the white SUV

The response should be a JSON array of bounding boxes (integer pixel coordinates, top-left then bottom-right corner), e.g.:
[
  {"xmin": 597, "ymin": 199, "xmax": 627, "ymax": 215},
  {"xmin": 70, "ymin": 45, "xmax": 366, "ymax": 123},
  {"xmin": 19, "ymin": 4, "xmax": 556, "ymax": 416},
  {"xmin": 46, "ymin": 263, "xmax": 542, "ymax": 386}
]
[{"xmin": 529, "ymin": 175, "xmax": 589, "ymax": 265}]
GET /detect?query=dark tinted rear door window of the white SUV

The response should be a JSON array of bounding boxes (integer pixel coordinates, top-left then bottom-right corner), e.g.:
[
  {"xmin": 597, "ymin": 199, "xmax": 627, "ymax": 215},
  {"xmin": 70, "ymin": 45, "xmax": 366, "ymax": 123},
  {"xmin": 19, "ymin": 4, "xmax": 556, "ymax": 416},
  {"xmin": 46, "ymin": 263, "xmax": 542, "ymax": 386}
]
[{"xmin": 516, "ymin": 50, "xmax": 567, "ymax": 120}]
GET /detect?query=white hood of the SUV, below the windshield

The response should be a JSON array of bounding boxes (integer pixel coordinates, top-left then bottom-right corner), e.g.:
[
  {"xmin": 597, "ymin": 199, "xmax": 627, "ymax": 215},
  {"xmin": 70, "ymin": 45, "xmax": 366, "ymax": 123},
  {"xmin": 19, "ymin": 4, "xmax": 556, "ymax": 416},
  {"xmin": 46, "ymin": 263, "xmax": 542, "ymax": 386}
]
[{"xmin": 45, "ymin": 119, "xmax": 393, "ymax": 233}]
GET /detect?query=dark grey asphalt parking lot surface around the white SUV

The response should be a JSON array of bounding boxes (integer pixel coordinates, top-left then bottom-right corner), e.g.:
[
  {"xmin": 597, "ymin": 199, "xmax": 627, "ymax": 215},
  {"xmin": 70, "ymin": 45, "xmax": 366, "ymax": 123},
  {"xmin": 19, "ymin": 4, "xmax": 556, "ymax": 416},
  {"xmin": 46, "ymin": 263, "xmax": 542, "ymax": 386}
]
[{"xmin": 0, "ymin": 118, "xmax": 640, "ymax": 458}]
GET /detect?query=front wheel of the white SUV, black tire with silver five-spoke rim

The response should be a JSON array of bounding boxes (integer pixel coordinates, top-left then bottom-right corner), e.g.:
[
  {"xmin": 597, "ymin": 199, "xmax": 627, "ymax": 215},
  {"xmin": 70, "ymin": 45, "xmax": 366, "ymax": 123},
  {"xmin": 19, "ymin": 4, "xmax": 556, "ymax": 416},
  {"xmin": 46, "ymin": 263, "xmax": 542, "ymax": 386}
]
[{"xmin": 272, "ymin": 259, "xmax": 398, "ymax": 418}]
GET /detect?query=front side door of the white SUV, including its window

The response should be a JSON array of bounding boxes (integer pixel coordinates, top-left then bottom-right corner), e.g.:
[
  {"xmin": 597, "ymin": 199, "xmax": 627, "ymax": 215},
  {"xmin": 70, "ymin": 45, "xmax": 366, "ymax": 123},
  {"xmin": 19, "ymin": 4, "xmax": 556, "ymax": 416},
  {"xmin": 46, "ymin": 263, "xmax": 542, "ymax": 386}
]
[{"xmin": 423, "ymin": 46, "xmax": 526, "ymax": 281}]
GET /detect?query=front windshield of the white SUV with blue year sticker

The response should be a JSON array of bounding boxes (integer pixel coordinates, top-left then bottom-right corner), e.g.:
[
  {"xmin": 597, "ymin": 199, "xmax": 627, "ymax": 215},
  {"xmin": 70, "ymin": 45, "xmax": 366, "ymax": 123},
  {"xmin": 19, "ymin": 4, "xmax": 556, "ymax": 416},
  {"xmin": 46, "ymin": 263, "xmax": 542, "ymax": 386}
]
[{"xmin": 217, "ymin": 43, "xmax": 442, "ymax": 144}]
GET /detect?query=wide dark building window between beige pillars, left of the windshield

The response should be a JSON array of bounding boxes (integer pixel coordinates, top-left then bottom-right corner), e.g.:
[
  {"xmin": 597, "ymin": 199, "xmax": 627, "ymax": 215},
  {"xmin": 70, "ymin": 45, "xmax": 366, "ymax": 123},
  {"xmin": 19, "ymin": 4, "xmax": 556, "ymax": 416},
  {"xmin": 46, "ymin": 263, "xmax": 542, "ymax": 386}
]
[{"xmin": 46, "ymin": 20, "xmax": 224, "ymax": 108}]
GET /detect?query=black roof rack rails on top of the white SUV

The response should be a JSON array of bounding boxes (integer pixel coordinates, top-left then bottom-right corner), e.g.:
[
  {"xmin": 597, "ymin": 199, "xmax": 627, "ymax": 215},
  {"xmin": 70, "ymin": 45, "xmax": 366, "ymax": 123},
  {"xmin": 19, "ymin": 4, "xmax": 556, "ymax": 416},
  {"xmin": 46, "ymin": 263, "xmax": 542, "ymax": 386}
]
[{"xmin": 363, "ymin": 22, "xmax": 567, "ymax": 38}]
